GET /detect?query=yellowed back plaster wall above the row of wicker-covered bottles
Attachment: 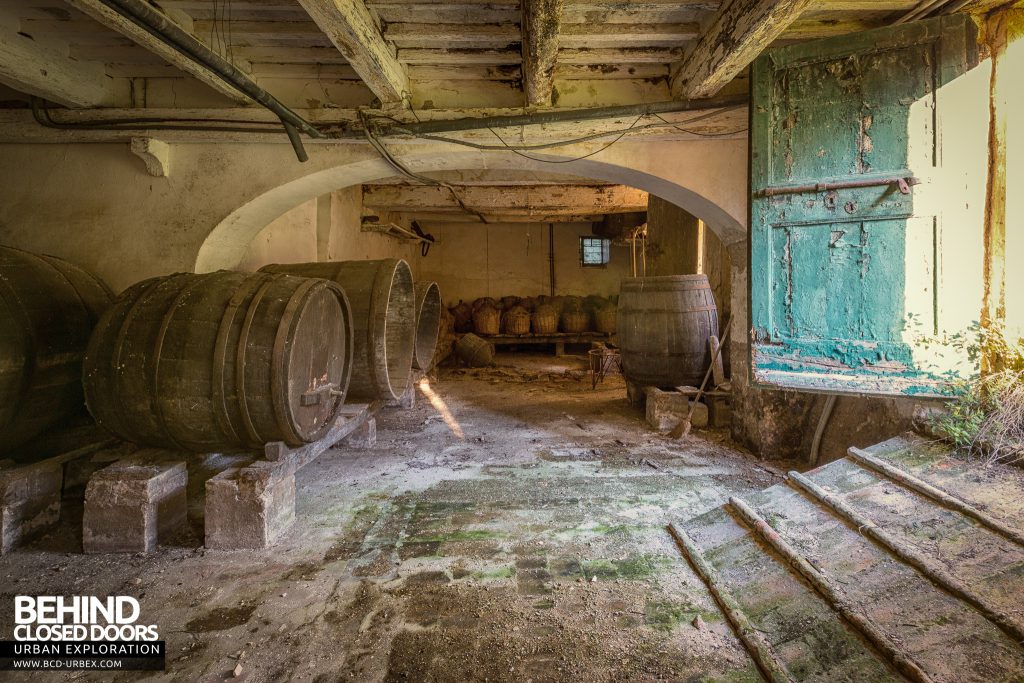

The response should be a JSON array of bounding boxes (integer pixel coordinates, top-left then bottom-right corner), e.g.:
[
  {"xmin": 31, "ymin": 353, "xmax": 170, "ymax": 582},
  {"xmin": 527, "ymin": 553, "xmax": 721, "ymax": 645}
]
[{"xmin": 415, "ymin": 223, "xmax": 631, "ymax": 303}]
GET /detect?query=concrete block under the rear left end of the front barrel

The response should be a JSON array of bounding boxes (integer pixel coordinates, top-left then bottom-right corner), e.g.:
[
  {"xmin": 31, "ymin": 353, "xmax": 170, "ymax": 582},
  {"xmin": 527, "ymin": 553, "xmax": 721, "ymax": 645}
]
[{"xmin": 82, "ymin": 460, "xmax": 188, "ymax": 553}]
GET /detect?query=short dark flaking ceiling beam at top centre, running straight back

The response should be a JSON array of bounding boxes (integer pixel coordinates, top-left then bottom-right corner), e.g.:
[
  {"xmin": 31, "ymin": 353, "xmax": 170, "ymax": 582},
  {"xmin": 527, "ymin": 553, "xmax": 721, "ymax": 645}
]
[{"xmin": 522, "ymin": 0, "xmax": 563, "ymax": 106}]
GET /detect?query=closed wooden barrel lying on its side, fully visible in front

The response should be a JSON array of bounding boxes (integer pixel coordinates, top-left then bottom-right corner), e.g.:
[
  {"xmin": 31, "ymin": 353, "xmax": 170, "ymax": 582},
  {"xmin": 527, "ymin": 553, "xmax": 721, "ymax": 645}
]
[{"xmin": 83, "ymin": 271, "xmax": 352, "ymax": 452}]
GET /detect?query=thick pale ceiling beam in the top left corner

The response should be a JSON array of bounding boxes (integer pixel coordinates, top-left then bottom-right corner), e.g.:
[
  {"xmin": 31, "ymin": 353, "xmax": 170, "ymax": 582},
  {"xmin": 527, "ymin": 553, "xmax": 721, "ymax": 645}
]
[{"xmin": 0, "ymin": 10, "xmax": 120, "ymax": 106}]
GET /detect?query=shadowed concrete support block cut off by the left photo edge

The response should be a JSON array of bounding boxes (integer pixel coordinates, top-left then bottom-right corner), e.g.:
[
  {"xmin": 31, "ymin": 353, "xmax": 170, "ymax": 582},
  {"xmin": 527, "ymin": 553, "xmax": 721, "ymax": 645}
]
[{"xmin": 0, "ymin": 461, "xmax": 63, "ymax": 555}]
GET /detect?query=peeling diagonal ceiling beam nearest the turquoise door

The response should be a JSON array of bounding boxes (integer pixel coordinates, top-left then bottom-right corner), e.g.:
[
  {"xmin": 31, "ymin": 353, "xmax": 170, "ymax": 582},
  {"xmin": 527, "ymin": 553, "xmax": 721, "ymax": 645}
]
[{"xmin": 672, "ymin": 0, "xmax": 811, "ymax": 99}]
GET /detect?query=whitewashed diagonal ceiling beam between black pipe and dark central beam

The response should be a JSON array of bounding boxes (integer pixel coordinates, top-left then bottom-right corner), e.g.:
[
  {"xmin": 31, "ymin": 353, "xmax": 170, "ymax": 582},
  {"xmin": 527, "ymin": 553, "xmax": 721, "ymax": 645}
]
[{"xmin": 299, "ymin": 0, "xmax": 410, "ymax": 105}]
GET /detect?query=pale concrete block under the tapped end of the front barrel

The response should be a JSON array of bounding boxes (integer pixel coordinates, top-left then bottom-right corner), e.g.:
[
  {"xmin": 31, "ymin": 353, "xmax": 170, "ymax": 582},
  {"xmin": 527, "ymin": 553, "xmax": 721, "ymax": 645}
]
[{"xmin": 206, "ymin": 462, "xmax": 295, "ymax": 550}]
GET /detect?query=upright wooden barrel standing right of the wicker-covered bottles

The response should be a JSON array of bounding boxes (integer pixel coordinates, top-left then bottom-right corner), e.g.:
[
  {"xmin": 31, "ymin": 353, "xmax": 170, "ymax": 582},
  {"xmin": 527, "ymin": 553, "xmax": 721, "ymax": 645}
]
[{"xmin": 617, "ymin": 275, "xmax": 718, "ymax": 388}]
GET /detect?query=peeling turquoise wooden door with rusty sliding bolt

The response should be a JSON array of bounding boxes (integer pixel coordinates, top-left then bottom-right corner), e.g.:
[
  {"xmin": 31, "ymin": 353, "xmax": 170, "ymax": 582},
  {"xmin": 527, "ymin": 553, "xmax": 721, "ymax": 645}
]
[{"xmin": 751, "ymin": 16, "xmax": 980, "ymax": 394}]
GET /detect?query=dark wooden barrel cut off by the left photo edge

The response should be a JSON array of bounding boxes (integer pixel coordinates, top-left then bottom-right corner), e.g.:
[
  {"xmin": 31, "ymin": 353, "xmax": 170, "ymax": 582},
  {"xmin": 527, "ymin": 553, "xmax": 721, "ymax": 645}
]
[{"xmin": 0, "ymin": 247, "xmax": 114, "ymax": 455}]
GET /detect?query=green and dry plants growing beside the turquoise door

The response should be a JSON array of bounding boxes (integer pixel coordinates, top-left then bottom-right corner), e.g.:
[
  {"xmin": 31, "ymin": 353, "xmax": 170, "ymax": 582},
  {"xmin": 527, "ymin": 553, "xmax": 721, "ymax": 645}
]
[{"xmin": 932, "ymin": 325, "xmax": 1024, "ymax": 464}]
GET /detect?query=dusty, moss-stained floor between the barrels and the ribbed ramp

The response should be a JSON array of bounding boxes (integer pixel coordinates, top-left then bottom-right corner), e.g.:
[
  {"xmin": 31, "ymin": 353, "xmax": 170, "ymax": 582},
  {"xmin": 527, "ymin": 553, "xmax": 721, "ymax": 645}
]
[{"xmin": 0, "ymin": 355, "xmax": 778, "ymax": 681}]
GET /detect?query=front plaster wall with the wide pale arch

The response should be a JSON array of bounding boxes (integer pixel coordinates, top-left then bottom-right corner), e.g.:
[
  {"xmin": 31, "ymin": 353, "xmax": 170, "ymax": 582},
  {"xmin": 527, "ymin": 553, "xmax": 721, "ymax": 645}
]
[{"xmin": 0, "ymin": 139, "xmax": 746, "ymax": 290}]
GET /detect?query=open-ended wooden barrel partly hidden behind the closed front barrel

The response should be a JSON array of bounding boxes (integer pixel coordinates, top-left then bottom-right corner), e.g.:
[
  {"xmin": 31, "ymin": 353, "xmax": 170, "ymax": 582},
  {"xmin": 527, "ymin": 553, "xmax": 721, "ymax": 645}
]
[{"xmin": 260, "ymin": 259, "xmax": 416, "ymax": 400}]
